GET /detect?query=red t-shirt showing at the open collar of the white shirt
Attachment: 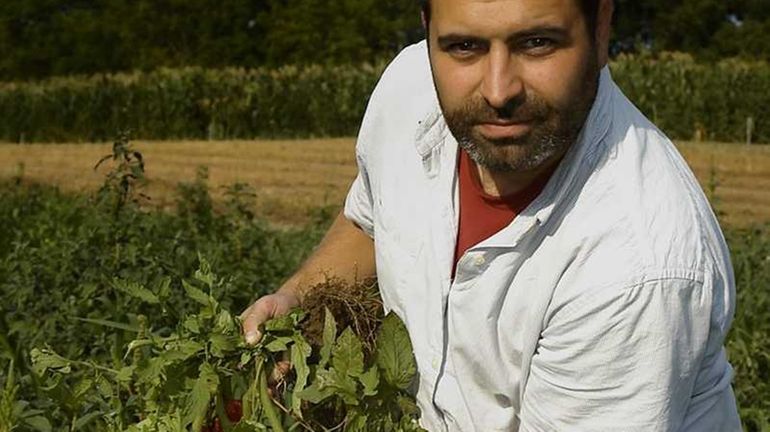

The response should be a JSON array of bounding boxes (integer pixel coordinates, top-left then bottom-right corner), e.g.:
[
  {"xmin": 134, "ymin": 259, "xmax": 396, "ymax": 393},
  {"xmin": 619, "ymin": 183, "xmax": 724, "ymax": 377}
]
[{"xmin": 452, "ymin": 149, "xmax": 555, "ymax": 277}]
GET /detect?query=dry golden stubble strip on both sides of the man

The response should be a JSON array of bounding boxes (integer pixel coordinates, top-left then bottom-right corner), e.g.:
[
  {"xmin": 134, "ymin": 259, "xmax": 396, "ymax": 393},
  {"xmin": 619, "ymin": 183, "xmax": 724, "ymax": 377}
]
[{"xmin": 0, "ymin": 138, "xmax": 770, "ymax": 227}]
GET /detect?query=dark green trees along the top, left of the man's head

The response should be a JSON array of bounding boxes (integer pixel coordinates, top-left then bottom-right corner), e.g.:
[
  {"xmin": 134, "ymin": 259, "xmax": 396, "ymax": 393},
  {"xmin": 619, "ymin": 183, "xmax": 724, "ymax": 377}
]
[{"xmin": 0, "ymin": 0, "xmax": 420, "ymax": 80}]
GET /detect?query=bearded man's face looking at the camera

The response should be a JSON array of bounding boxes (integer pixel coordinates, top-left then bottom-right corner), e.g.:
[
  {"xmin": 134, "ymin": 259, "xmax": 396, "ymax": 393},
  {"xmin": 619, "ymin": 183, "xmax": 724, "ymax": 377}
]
[{"xmin": 428, "ymin": 0, "xmax": 599, "ymax": 172}]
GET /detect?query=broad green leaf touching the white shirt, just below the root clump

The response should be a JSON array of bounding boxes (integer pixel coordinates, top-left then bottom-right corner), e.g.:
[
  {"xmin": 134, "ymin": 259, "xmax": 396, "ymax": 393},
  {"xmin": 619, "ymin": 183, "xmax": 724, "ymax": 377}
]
[{"xmin": 375, "ymin": 312, "xmax": 417, "ymax": 390}]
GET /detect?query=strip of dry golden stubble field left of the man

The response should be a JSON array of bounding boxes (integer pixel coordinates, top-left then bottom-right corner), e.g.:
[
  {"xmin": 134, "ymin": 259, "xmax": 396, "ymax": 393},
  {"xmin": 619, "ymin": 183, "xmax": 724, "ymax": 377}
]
[{"xmin": 0, "ymin": 139, "xmax": 356, "ymax": 225}]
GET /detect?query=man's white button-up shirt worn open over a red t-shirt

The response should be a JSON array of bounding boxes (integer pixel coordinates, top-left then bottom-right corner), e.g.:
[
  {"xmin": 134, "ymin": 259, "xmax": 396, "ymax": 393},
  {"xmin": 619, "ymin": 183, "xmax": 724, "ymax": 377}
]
[{"xmin": 345, "ymin": 42, "xmax": 740, "ymax": 432}]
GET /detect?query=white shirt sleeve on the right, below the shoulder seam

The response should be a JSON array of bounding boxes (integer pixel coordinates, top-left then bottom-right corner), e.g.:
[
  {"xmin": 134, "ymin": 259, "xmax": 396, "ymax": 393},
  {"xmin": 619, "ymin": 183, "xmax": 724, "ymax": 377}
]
[{"xmin": 520, "ymin": 279, "xmax": 740, "ymax": 432}]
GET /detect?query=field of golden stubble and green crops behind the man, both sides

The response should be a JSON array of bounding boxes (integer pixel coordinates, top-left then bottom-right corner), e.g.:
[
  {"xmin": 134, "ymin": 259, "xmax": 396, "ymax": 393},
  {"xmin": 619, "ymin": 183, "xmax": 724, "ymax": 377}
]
[{"xmin": 0, "ymin": 139, "xmax": 770, "ymax": 432}]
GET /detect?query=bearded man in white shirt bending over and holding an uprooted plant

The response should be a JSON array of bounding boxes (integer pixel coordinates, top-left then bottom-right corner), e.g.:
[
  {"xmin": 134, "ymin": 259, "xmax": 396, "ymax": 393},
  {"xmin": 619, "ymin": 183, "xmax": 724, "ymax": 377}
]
[{"xmin": 243, "ymin": 0, "xmax": 740, "ymax": 431}]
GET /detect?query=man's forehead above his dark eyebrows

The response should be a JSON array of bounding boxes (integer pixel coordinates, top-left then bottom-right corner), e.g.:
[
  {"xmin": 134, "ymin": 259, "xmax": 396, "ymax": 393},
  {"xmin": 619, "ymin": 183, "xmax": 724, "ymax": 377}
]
[{"xmin": 431, "ymin": 0, "xmax": 583, "ymax": 34}]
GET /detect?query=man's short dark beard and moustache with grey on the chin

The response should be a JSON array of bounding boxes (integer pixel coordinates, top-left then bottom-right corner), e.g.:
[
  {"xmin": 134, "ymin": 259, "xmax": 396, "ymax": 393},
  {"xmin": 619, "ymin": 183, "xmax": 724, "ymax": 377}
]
[{"xmin": 439, "ymin": 56, "xmax": 599, "ymax": 173}]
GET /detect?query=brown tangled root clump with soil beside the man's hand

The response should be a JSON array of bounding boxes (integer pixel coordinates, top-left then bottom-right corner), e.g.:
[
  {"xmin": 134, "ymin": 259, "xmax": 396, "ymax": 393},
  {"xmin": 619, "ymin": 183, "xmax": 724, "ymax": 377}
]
[{"xmin": 301, "ymin": 278, "xmax": 384, "ymax": 358}]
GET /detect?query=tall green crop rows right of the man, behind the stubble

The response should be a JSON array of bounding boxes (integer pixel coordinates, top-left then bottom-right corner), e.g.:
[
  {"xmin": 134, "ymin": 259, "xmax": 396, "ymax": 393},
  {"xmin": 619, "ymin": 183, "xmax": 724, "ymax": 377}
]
[{"xmin": 611, "ymin": 54, "xmax": 770, "ymax": 143}]
